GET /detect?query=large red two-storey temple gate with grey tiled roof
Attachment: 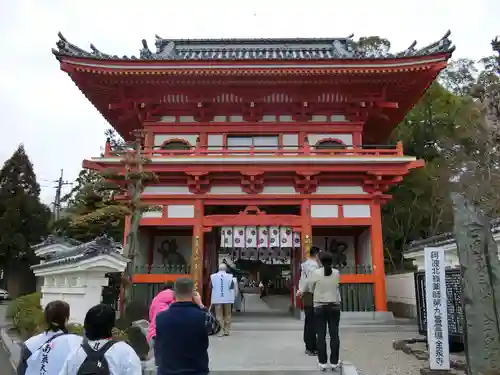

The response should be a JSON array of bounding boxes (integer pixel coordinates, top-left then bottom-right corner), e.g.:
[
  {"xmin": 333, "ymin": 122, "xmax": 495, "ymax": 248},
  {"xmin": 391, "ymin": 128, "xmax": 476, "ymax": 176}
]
[{"xmin": 53, "ymin": 33, "xmax": 453, "ymax": 312}]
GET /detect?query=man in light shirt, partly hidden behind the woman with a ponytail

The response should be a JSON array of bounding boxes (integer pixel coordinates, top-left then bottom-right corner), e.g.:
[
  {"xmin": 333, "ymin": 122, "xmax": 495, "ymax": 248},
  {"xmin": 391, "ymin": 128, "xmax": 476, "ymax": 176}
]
[{"xmin": 297, "ymin": 246, "xmax": 319, "ymax": 356}]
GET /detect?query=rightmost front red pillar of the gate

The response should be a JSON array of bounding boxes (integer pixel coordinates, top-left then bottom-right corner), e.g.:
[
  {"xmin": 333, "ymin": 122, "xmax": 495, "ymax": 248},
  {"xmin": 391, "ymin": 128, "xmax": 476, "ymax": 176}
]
[{"xmin": 370, "ymin": 200, "xmax": 387, "ymax": 311}]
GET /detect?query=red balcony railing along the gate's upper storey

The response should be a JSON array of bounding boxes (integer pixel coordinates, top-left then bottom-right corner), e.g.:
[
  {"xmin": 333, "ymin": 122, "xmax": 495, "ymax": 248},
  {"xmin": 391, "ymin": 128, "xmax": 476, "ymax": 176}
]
[{"xmin": 104, "ymin": 143, "xmax": 404, "ymax": 158}]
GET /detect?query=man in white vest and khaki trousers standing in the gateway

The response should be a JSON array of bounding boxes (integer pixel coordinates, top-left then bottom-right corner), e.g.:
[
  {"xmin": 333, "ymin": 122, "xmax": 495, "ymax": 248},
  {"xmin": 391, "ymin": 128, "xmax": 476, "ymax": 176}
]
[{"xmin": 210, "ymin": 263, "xmax": 235, "ymax": 336}]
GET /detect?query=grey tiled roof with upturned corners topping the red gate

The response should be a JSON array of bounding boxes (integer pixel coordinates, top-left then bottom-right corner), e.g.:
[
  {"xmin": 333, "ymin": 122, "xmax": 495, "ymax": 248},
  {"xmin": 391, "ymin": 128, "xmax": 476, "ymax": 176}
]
[{"xmin": 52, "ymin": 31, "xmax": 454, "ymax": 61}]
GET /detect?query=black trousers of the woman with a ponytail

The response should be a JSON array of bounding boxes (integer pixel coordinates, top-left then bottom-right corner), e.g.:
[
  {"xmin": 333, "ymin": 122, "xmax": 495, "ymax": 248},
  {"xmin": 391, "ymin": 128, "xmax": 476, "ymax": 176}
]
[{"xmin": 314, "ymin": 303, "xmax": 340, "ymax": 365}]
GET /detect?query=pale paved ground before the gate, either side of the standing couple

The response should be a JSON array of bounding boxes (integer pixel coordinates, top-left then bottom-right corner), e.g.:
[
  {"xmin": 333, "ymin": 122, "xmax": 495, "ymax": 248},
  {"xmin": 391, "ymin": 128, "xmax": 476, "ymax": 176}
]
[{"xmin": 209, "ymin": 317, "xmax": 423, "ymax": 375}]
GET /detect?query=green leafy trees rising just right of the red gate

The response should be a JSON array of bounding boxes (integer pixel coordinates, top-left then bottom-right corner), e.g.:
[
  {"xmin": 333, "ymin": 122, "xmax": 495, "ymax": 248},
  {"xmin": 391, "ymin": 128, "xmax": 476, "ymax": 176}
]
[{"xmin": 382, "ymin": 47, "xmax": 500, "ymax": 269}]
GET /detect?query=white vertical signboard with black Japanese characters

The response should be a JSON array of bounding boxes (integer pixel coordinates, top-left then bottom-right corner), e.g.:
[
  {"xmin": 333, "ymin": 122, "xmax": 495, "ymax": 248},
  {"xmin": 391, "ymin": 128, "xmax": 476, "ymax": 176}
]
[{"xmin": 425, "ymin": 247, "xmax": 450, "ymax": 370}]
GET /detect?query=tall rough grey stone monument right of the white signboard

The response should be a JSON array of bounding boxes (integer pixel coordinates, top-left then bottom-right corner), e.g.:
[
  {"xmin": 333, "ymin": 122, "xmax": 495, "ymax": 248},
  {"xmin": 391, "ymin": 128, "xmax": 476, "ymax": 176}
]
[{"xmin": 451, "ymin": 193, "xmax": 500, "ymax": 375}]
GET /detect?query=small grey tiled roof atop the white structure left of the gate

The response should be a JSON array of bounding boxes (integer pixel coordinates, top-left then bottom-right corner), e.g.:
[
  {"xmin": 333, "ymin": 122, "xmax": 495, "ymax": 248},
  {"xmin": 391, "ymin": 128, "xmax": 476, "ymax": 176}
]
[{"xmin": 31, "ymin": 236, "xmax": 123, "ymax": 269}]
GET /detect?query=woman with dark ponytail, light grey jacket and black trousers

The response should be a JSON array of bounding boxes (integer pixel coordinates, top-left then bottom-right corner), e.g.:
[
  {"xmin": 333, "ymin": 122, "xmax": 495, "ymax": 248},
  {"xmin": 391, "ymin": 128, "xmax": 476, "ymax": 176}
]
[{"xmin": 307, "ymin": 252, "xmax": 341, "ymax": 371}]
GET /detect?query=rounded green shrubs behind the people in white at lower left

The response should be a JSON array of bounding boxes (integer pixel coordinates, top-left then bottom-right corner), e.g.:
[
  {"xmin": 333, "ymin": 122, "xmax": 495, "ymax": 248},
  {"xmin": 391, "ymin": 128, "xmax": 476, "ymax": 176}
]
[{"xmin": 6, "ymin": 293, "xmax": 127, "ymax": 341}]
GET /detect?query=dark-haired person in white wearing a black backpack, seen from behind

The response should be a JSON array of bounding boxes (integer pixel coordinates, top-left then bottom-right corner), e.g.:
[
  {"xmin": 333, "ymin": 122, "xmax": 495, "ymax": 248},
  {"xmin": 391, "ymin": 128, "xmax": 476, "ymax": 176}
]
[{"xmin": 58, "ymin": 304, "xmax": 142, "ymax": 375}]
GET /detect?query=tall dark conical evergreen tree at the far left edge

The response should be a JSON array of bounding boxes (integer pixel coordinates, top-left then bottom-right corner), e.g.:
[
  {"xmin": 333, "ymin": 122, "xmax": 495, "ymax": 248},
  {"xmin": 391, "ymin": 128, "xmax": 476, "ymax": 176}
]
[{"xmin": 0, "ymin": 145, "xmax": 51, "ymax": 294}]
